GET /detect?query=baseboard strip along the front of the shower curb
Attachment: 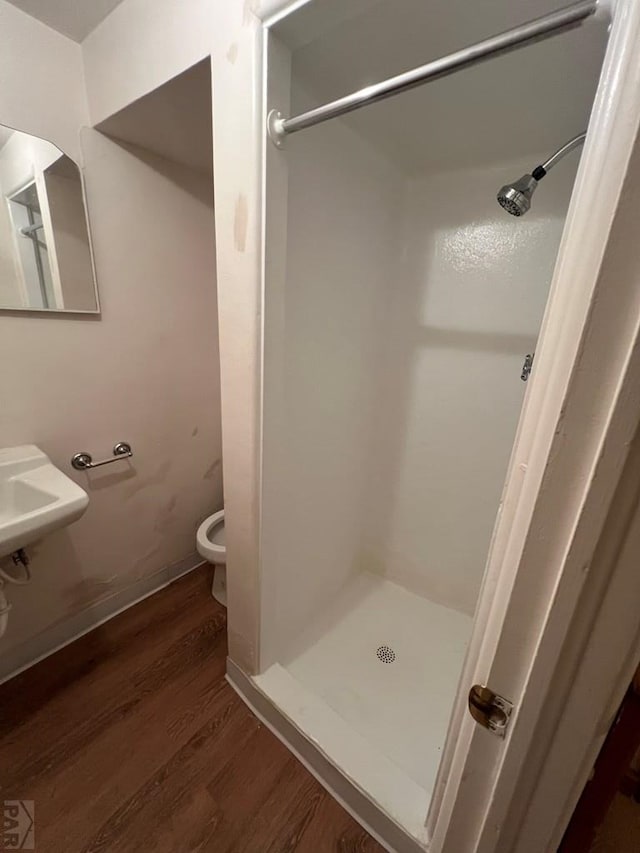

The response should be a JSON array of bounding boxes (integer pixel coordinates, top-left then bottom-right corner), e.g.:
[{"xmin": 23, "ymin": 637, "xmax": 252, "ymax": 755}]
[{"xmin": 227, "ymin": 658, "xmax": 425, "ymax": 853}]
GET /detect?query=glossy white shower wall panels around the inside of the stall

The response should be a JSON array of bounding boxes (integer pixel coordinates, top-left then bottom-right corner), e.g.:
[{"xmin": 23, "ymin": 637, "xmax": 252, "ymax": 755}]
[{"xmin": 261, "ymin": 93, "xmax": 577, "ymax": 669}]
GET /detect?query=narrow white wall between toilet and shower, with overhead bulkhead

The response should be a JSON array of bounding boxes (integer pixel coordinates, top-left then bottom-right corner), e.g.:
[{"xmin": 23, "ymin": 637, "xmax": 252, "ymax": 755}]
[{"xmin": 83, "ymin": 0, "xmax": 270, "ymax": 672}]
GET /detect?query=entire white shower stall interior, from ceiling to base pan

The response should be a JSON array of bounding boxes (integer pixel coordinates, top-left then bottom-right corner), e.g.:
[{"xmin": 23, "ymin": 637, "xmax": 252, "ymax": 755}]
[{"xmin": 216, "ymin": 0, "xmax": 640, "ymax": 850}]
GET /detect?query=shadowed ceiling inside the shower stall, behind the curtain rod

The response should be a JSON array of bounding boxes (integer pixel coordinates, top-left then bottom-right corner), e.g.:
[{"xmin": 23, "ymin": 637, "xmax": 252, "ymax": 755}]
[{"xmin": 276, "ymin": 0, "xmax": 606, "ymax": 174}]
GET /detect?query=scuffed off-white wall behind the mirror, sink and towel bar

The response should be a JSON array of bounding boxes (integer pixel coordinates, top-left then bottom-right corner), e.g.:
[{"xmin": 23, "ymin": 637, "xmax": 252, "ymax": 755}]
[{"xmin": 0, "ymin": 4, "xmax": 222, "ymax": 674}]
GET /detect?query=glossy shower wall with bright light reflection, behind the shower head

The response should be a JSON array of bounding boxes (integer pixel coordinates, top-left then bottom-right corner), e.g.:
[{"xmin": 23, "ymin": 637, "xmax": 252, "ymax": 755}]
[{"xmin": 362, "ymin": 158, "xmax": 577, "ymax": 613}]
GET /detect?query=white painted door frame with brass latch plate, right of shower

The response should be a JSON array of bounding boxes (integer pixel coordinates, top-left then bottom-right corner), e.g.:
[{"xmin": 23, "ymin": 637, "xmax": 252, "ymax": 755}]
[{"xmin": 428, "ymin": 0, "xmax": 640, "ymax": 853}]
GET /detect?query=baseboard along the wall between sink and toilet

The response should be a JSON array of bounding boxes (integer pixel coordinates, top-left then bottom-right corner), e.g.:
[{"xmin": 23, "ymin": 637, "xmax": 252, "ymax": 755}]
[{"xmin": 0, "ymin": 554, "xmax": 204, "ymax": 684}]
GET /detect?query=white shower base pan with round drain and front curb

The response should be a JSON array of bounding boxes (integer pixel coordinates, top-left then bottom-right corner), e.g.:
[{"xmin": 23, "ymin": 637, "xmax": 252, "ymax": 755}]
[{"xmin": 228, "ymin": 573, "xmax": 471, "ymax": 851}]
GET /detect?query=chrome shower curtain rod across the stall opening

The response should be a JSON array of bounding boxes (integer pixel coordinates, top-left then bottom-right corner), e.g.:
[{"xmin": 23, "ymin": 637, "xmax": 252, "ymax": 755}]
[{"xmin": 267, "ymin": 0, "xmax": 598, "ymax": 146}]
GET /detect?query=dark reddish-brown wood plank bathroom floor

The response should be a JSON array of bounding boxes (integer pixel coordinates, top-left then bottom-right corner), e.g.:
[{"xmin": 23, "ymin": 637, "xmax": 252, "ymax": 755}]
[{"xmin": 0, "ymin": 569, "xmax": 382, "ymax": 853}]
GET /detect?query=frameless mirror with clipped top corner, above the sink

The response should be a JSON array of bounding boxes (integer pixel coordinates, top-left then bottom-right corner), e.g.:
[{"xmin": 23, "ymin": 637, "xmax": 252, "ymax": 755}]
[{"xmin": 0, "ymin": 125, "xmax": 99, "ymax": 313}]
